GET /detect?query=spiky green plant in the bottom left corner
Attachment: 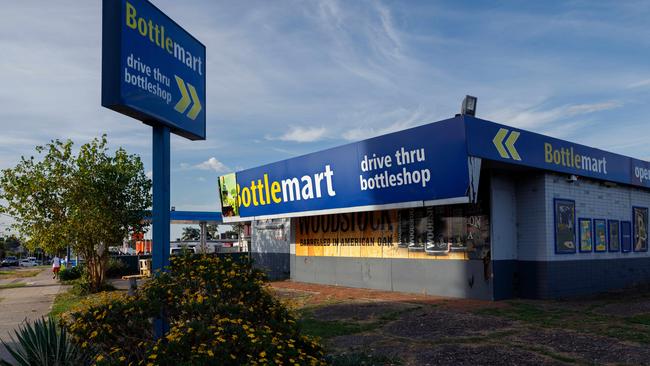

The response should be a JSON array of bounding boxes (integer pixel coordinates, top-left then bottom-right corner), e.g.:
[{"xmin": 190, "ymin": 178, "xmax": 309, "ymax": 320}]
[{"xmin": 0, "ymin": 318, "xmax": 90, "ymax": 366}]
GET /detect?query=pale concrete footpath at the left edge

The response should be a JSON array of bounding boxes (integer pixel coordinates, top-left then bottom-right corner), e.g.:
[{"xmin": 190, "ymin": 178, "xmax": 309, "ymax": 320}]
[{"xmin": 0, "ymin": 269, "xmax": 61, "ymax": 362}]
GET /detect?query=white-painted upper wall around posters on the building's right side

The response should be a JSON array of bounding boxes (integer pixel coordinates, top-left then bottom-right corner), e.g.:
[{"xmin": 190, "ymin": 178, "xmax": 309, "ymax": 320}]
[{"xmin": 492, "ymin": 172, "xmax": 650, "ymax": 261}]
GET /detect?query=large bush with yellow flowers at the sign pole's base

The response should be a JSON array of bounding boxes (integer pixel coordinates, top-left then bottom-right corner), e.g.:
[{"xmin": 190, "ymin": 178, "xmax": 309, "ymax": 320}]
[{"xmin": 63, "ymin": 256, "xmax": 324, "ymax": 366}]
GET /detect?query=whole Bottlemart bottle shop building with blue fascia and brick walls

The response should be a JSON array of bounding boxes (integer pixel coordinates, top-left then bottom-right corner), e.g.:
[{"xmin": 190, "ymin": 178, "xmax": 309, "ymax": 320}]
[{"xmin": 219, "ymin": 115, "xmax": 650, "ymax": 300}]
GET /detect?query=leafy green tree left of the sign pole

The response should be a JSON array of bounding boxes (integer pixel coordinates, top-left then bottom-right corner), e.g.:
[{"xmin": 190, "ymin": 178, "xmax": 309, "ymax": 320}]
[{"xmin": 0, "ymin": 135, "xmax": 151, "ymax": 291}]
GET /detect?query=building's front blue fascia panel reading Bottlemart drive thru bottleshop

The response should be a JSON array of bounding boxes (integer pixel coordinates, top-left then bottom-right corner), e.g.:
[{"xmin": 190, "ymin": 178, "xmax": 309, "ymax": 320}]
[{"xmin": 225, "ymin": 118, "xmax": 469, "ymax": 219}]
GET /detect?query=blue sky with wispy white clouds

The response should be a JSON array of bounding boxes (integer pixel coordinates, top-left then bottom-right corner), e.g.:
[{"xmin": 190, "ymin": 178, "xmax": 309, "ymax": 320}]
[{"xmin": 0, "ymin": 0, "xmax": 650, "ymax": 237}]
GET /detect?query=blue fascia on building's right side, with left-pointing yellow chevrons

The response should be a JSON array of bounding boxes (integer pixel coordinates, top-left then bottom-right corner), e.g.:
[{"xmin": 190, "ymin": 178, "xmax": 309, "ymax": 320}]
[{"xmin": 463, "ymin": 116, "xmax": 650, "ymax": 188}]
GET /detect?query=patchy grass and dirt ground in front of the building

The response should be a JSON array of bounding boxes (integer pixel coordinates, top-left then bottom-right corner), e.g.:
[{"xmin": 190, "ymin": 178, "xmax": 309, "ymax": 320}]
[{"xmin": 270, "ymin": 282, "xmax": 650, "ymax": 365}]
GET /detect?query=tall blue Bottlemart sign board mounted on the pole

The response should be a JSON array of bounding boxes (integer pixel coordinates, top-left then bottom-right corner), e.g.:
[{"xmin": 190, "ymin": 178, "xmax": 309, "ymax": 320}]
[{"xmin": 102, "ymin": 0, "xmax": 206, "ymax": 140}]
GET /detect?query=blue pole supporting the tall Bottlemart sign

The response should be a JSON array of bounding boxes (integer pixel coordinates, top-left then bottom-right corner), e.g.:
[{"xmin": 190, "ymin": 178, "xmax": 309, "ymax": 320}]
[{"xmin": 151, "ymin": 125, "xmax": 170, "ymax": 272}]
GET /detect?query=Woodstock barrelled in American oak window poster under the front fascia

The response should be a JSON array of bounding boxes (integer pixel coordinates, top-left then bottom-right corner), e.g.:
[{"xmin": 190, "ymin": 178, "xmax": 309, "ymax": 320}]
[{"xmin": 296, "ymin": 205, "xmax": 490, "ymax": 259}]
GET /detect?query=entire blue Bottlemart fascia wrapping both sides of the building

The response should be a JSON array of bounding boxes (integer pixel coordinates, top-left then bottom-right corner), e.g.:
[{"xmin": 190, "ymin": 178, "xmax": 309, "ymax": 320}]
[{"xmin": 220, "ymin": 116, "xmax": 650, "ymax": 220}]
